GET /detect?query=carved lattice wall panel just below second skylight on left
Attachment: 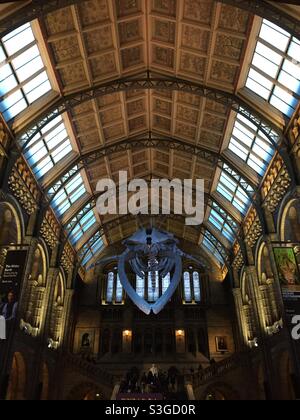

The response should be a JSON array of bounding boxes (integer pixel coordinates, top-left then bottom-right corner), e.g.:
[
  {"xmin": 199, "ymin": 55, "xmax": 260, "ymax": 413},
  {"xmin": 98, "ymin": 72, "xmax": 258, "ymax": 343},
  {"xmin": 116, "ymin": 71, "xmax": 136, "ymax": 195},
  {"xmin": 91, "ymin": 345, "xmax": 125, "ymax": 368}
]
[{"xmin": 8, "ymin": 157, "xmax": 40, "ymax": 215}]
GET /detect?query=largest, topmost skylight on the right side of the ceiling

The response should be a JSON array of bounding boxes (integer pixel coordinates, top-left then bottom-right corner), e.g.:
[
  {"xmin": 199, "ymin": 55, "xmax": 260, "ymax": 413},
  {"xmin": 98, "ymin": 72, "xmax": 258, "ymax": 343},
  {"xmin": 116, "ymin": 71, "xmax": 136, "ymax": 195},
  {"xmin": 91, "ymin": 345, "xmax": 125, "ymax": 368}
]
[{"xmin": 246, "ymin": 20, "xmax": 300, "ymax": 117}]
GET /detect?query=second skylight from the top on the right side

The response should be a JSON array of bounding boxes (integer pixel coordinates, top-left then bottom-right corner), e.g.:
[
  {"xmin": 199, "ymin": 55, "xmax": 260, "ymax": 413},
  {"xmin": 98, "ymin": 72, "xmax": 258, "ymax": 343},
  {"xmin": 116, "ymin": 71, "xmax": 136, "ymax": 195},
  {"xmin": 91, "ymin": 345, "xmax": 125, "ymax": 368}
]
[{"xmin": 229, "ymin": 114, "xmax": 274, "ymax": 176}]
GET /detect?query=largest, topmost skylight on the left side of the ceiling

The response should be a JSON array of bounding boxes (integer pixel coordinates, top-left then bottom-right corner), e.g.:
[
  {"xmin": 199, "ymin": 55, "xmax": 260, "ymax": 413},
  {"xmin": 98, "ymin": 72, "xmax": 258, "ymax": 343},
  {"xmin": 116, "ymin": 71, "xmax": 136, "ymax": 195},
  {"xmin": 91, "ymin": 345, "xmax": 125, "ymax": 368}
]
[{"xmin": 0, "ymin": 23, "xmax": 52, "ymax": 121}]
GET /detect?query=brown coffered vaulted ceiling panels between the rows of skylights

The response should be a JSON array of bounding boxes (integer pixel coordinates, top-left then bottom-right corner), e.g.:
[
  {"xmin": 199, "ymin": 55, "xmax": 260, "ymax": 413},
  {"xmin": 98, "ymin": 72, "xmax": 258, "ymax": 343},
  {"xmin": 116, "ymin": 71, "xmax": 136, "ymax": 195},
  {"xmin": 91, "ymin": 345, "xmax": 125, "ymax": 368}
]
[{"xmin": 0, "ymin": 0, "xmax": 300, "ymax": 270}]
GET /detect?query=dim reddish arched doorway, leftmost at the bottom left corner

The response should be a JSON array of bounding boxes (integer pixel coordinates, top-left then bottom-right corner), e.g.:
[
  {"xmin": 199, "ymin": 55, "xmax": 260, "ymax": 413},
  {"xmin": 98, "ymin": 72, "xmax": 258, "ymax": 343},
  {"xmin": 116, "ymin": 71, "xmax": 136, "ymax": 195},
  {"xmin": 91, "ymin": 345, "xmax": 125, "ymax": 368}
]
[{"xmin": 6, "ymin": 353, "xmax": 26, "ymax": 401}]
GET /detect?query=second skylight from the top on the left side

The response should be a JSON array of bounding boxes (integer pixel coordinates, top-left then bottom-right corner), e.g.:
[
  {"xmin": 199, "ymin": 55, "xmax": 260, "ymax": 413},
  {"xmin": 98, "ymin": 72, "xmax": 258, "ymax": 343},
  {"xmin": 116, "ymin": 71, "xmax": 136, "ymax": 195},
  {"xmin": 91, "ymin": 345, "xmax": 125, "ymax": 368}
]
[{"xmin": 24, "ymin": 116, "xmax": 72, "ymax": 179}]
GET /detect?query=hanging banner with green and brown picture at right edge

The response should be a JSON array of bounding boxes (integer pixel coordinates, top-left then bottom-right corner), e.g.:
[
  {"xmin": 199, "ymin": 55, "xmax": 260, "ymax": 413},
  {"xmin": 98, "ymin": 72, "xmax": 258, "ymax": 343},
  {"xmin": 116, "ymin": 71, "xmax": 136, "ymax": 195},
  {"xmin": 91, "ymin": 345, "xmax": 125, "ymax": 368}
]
[{"xmin": 273, "ymin": 244, "xmax": 300, "ymax": 330}]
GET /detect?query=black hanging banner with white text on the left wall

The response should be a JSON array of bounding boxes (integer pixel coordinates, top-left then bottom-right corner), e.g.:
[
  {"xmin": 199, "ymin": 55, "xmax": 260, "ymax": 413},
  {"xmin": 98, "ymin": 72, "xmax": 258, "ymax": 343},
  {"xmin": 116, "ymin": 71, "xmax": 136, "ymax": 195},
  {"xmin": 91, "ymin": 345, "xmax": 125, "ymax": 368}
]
[{"xmin": 0, "ymin": 250, "xmax": 27, "ymax": 321}]
